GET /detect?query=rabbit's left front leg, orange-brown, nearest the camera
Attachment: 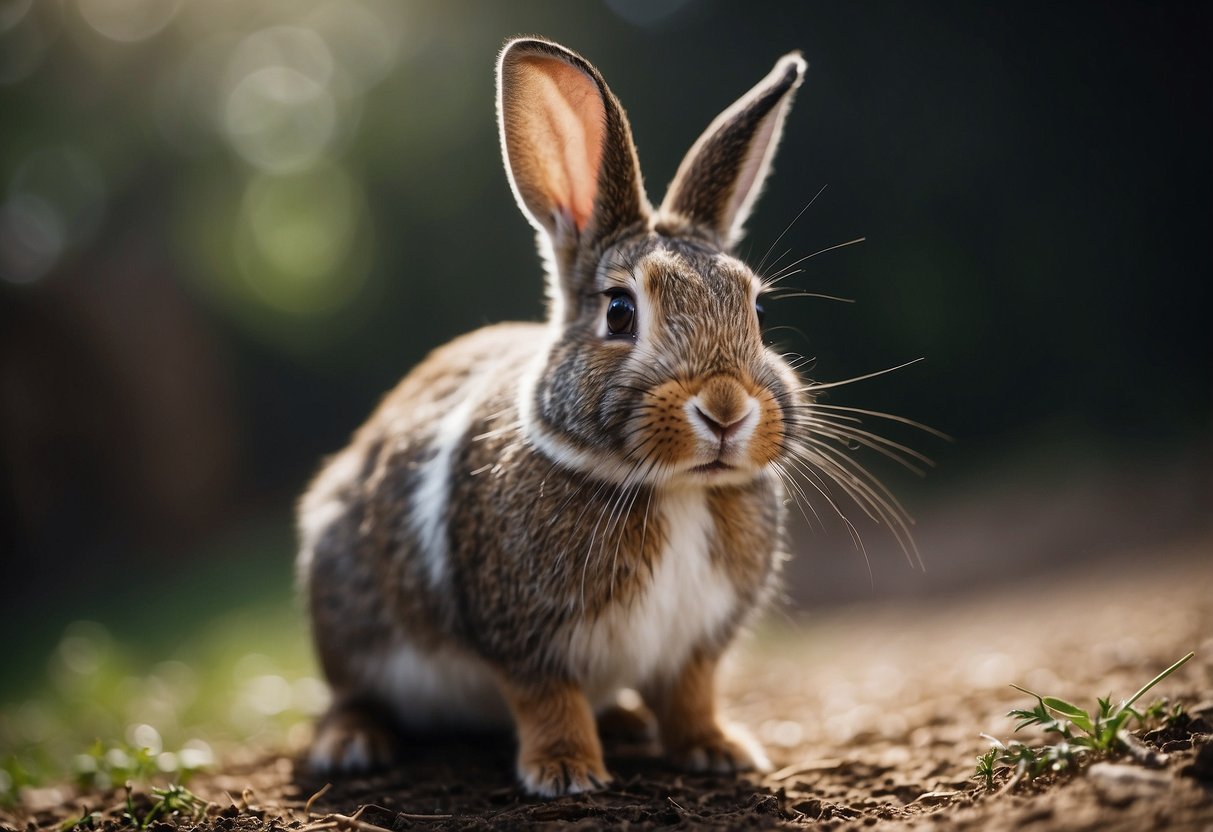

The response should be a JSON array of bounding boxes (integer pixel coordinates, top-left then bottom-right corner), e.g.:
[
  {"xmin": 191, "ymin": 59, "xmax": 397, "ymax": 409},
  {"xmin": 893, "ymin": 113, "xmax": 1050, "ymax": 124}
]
[{"xmin": 502, "ymin": 679, "xmax": 610, "ymax": 797}]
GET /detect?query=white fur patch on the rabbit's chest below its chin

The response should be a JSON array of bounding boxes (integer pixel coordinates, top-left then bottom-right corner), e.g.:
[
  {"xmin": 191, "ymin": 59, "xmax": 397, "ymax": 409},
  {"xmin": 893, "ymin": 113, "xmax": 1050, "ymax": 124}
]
[{"xmin": 569, "ymin": 489, "xmax": 738, "ymax": 705}]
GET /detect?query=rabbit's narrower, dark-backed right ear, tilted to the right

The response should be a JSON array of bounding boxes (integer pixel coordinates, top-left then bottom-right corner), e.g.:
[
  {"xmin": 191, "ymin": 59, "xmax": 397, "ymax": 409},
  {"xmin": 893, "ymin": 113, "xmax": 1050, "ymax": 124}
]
[{"xmin": 661, "ymin": 52, "xmax": 808, "ymax": 249}]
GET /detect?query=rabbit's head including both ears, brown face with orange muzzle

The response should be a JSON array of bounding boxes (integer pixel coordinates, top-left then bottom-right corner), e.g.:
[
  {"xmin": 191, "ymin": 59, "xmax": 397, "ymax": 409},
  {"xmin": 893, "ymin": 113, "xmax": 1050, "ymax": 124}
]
[{"xmin": 497, "ymin": 38, "xmax": 805, "ymax": 485}]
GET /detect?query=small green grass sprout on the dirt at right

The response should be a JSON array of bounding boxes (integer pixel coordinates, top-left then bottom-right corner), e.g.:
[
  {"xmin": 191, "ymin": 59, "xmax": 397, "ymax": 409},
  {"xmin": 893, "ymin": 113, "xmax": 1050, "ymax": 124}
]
[{"xmin": 973, "ymin": 653, "xmax": 1196, "ymax": 790}]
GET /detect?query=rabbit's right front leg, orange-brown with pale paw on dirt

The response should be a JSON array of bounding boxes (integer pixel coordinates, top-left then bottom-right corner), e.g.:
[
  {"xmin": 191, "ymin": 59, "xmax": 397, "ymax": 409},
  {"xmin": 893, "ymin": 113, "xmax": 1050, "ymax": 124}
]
[{"xmin": 644, "ymin": 654, "xmax": 770, "ymax": 773}]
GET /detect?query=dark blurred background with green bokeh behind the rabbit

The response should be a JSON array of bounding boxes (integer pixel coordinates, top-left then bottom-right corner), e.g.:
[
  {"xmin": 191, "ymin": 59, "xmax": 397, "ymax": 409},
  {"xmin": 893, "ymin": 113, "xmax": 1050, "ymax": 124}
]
[{"xmin": 0, "ymin": 0, "xmax": 1213, "ymax": 800}]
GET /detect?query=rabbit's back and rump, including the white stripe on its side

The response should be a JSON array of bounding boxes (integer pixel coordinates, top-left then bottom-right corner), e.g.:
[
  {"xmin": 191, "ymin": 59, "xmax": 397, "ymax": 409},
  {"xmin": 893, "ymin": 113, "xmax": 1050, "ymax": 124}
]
[{"xmin": 297, "ymin": 324, "xmax": 543, "ymax": 726}]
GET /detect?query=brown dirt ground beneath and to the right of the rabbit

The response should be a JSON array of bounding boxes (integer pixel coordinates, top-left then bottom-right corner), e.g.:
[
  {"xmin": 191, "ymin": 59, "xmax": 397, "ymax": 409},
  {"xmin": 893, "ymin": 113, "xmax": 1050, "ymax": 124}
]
[{"xmin": 0, "ymin": 540, "xmax": 1213, "ymax": 832}]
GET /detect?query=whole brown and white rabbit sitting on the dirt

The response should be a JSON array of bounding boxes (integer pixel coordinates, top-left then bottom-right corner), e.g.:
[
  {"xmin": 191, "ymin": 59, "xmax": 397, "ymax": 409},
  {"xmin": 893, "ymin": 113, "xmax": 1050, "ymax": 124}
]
[{"xmin": 297, "ymin": 38, "xmax": 810, "ymax": 797}]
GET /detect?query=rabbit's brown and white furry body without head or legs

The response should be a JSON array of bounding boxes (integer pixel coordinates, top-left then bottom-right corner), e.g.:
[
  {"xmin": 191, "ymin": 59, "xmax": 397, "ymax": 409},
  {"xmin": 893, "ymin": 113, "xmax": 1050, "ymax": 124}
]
[{"xmin": 301, "ymin": 325, "xmax": 782, "ymax": 728}]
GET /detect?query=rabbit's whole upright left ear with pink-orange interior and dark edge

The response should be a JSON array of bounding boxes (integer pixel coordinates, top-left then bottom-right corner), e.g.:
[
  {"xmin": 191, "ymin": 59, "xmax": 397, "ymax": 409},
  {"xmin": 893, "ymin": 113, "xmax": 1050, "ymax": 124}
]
[{"xmin": 497, "ymin": 38, "xmax": 649, "ymax": 267}]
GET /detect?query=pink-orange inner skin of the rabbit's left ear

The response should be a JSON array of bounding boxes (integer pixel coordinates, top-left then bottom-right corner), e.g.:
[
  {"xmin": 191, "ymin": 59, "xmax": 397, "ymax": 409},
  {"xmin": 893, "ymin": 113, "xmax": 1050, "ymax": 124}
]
[{"xmin": 507, "ymin": 56, "xmax": 605, "ymax": 232}]
